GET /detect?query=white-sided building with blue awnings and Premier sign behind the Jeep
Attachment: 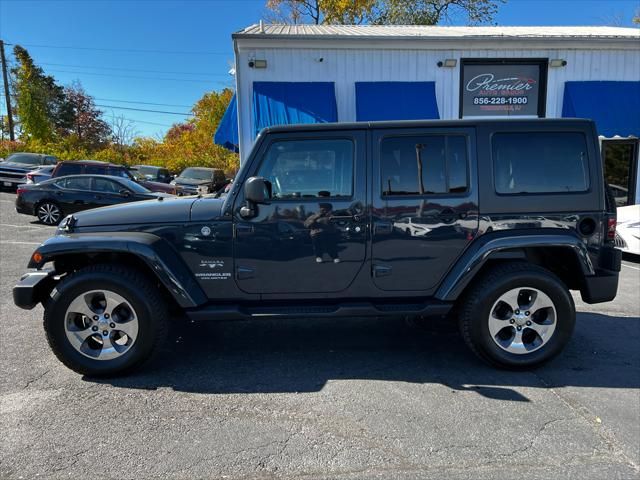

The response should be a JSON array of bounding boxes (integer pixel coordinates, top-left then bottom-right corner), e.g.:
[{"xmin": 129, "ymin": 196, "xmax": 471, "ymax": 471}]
[{"xmin": 216, "ymin": 25, "xmax": 640, "ymax": 203}]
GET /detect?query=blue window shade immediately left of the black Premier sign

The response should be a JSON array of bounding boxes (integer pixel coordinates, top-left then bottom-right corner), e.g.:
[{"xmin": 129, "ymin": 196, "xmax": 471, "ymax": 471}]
[{"xmin": 356, "ymin": 82, "xmax": 440, "ymax": 122}]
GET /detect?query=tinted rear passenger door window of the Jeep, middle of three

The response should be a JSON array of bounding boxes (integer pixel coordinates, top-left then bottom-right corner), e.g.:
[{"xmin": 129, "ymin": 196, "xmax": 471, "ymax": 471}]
[{"xmin": 380, "ymin": 135, "xmax": 468, "ymax": 195}]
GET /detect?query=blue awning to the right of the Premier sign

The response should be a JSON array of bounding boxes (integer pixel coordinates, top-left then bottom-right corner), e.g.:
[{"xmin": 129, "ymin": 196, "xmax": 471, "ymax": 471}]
[{"xmin": 562, "ymin": 81, "xmax": 640, "ymax": 137}]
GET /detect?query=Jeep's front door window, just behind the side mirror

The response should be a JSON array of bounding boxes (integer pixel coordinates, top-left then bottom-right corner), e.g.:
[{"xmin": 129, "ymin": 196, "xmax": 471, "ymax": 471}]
[{"xmin": 258, "ymin": 139, "xmax": 353, "ymax": 198}]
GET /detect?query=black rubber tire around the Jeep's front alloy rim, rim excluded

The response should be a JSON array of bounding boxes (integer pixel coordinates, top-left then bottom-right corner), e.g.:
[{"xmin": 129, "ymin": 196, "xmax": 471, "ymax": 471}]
[{"xmin": 43, "ymin": 265, "xmax": 169, "ymax": 376}]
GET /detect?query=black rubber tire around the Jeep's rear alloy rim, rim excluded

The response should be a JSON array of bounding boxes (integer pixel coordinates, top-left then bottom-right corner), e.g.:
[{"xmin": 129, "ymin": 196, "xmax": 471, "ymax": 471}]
[{"xmin": 459, "ymin": 262, "xmax": 576, "ymax": 370}]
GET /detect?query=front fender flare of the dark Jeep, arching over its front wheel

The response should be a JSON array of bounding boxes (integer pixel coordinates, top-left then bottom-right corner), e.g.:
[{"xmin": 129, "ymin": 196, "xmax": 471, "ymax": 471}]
[{"xmin": 29, "ymin": 232, "xmax": 207, "ymax": 308}]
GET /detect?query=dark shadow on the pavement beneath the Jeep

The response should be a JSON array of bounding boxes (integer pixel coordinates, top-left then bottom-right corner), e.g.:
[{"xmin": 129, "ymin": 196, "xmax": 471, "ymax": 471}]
[{"xmin": 91, "ymin": 313, "xmax": 640, "ymax": 402}]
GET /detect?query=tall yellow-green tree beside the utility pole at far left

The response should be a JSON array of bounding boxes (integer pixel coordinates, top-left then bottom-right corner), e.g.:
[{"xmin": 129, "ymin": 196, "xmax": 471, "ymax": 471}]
[{"xmin": 11, "ymin": 45, "xmax": 73, "ymax": 142}]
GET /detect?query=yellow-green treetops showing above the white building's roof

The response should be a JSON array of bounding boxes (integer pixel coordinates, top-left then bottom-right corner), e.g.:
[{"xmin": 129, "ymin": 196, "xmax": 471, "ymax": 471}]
[{"xmin": 266, "ymin": 0, "xmax": 506, "ymax": 25}]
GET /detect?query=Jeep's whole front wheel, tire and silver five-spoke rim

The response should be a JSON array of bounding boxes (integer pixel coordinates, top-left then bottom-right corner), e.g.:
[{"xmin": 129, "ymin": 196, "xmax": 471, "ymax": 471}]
[{"xmin": 44, "ymin": 265, "xmax": 168, "ymax": 376}]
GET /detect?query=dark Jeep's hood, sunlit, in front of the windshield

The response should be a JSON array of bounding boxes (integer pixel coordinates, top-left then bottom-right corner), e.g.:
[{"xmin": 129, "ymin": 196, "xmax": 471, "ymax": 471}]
[{"xmin": 73, "ymin": 194, "xmax": 197, "ymax": 228}]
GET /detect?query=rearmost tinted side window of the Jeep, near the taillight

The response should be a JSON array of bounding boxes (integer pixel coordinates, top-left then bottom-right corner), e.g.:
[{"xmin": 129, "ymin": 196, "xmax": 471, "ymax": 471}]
[{"xmin": 491, "ymin": 132, "xmax": 589, "ymax": 195}]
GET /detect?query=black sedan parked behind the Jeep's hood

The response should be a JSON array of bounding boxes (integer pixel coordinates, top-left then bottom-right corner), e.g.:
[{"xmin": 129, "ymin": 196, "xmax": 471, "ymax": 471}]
[{"xmin": 16, "ymin": 175, "xmax": 170, "ymax": 225}]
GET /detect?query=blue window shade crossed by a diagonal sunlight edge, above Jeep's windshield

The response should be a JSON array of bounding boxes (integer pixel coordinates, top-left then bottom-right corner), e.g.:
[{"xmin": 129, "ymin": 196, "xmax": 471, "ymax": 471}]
[{"xmin": 253, "ymin": 82, "xmax": 338, "ymax": 135}]
